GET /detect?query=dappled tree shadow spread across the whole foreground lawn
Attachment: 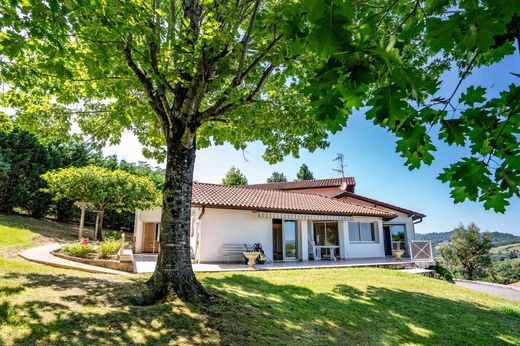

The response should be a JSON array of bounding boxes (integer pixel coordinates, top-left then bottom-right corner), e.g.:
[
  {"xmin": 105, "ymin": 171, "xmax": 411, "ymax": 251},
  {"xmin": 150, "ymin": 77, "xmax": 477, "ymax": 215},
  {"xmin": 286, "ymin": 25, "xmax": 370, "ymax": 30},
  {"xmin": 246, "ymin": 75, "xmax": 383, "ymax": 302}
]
[{"xmin": 0, "ymin": 273, "xmax": 520, "ymax": 345}]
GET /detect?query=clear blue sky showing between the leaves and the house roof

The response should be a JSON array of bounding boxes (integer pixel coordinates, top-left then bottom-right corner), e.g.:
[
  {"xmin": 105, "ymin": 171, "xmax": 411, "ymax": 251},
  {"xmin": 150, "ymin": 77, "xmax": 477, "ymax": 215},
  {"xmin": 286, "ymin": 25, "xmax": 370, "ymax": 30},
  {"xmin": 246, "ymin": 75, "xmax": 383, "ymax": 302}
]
[{"xmin": 105, "ymin": 52, "xmax": 520, "ymax": 235}]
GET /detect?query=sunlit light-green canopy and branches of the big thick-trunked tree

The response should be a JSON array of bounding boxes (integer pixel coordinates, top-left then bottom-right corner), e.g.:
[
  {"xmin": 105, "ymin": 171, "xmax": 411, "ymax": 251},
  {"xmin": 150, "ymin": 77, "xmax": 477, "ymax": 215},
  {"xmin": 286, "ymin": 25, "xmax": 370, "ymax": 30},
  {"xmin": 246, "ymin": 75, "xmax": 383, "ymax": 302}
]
[{"xmin": 0, "ymin": 0, "xmax": 326, "ymax": 162}]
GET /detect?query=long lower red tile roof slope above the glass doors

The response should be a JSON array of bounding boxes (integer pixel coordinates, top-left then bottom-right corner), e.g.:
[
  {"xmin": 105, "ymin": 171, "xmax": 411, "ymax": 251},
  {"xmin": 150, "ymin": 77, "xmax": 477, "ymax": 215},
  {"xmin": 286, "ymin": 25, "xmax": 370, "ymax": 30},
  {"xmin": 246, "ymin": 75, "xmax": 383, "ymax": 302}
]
[{"xmin": 192, "ymin": 183, "xmax": 397, "ymax": 218}]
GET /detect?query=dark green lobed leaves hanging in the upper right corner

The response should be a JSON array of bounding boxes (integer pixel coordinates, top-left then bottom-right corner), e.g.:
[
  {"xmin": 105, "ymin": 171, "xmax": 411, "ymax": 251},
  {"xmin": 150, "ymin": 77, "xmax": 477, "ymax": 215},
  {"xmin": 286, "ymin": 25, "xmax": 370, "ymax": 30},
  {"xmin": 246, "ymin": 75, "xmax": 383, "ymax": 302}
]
[{"xmin": 287, "ymin": 0, "xmax": 520, "ymax": 212}]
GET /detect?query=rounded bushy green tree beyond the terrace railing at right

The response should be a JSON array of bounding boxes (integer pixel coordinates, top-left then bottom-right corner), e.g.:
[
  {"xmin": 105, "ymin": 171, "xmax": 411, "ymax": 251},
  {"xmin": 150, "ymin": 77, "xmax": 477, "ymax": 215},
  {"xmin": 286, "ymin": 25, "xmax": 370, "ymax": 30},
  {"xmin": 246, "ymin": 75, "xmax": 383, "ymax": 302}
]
[{"xmin": 437, "ymin": 223, "xmax": 493, "ymax": 280}]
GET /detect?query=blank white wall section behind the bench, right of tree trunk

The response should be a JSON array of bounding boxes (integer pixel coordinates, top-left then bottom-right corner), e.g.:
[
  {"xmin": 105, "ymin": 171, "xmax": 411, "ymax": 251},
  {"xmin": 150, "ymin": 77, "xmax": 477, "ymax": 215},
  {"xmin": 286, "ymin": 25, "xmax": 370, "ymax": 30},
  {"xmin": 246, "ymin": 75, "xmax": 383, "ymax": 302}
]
[{"xmin": 200, "ymin": 208, "xmax": 273, "ymax": 263}]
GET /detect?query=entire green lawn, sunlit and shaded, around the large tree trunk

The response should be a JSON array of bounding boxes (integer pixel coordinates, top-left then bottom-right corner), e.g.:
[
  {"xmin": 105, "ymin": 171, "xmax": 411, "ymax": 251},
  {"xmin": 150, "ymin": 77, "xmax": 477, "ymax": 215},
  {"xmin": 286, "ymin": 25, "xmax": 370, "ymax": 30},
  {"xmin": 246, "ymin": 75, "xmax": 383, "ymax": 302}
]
[{"xmin": 0, "ymin": 216, "xmax": 520, "ymax": 345}]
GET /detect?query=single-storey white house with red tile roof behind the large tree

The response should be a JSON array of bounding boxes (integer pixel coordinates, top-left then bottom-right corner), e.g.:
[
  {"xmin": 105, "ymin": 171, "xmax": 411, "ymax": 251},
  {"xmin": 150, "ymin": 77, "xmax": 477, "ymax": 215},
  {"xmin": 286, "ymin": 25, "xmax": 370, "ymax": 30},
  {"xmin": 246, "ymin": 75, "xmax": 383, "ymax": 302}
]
[{"xmin": 134, "ymin": 177, "xmax": 425, "ymax": 263}]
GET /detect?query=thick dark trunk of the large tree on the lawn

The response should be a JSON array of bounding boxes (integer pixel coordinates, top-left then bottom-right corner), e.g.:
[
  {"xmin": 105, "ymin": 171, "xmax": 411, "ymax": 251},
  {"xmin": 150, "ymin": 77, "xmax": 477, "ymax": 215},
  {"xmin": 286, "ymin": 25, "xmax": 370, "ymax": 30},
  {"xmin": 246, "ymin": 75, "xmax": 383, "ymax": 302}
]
[{"xmin": 147, "ymin": 132, "xmax": 208, "ymax": 302}]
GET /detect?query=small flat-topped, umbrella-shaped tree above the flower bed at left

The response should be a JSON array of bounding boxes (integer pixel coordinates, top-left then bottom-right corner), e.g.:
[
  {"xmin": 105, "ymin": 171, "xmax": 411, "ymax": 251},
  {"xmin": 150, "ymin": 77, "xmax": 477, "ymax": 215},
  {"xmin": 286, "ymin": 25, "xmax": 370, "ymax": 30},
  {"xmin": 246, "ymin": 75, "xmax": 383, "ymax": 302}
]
[{"xmin": 42, "ymin": 165, "xmax": 160, "ymax": 240}]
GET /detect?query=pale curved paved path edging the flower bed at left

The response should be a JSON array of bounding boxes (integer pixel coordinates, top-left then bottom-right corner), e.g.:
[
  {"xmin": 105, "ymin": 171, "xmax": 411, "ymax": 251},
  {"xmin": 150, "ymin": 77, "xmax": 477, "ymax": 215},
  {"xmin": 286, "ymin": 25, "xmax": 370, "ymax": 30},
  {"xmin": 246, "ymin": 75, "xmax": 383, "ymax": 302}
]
[{"xmin": 18, "ymin": 243, "xmax": 131, "ymax": 275}]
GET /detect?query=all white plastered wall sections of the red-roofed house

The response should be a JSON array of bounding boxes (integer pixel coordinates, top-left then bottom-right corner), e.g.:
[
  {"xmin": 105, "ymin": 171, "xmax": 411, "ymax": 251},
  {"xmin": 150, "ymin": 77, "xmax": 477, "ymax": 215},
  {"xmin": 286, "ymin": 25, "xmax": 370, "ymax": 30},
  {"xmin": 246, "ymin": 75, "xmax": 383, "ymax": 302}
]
[{"xmin": 134, "ymin": 208, "xmax": 415, "ymax": 263}]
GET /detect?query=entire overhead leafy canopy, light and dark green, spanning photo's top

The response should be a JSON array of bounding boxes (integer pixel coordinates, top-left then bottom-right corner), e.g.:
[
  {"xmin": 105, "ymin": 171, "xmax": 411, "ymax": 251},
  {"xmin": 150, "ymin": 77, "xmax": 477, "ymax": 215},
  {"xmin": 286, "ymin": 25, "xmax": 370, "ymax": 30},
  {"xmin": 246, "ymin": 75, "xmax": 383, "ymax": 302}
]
[{"xmin": 0, "ymin": 0, "xmax": 520, "ymax": 212}]
